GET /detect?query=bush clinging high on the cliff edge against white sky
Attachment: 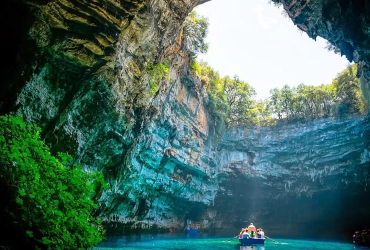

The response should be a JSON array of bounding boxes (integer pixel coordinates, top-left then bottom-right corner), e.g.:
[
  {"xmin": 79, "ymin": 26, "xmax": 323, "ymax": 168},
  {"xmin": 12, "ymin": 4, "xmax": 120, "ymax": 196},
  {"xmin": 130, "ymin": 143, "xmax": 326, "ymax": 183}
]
[{"xmin": 183, "ymin": 11, "xmax": 209, "ymax": 58}]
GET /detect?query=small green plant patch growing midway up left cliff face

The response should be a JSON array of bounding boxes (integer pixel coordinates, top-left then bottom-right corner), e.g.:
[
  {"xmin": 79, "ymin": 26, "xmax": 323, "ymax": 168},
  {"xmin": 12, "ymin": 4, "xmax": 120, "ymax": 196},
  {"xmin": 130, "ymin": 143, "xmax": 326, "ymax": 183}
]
[{"xmin": 146, "ymin": 60, "xmax": 170, "ymax": 96}]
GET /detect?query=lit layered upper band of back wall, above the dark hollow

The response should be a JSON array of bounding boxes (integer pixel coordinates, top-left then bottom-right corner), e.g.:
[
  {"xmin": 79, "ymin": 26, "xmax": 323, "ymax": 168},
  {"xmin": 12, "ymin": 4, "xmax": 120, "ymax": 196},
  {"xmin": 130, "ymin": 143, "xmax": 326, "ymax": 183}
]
[{"xmin": 221, "ymin": 118, "xmax": 370, "ymax": 196}]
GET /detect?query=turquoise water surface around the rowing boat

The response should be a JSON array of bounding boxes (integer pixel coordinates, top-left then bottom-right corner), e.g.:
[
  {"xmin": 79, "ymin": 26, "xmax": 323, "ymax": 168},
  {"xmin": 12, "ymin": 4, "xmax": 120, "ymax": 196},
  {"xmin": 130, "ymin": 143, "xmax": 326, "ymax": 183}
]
[{"xmin": 93, "ymin": 236, "xmax": 370, "ymax": 250}]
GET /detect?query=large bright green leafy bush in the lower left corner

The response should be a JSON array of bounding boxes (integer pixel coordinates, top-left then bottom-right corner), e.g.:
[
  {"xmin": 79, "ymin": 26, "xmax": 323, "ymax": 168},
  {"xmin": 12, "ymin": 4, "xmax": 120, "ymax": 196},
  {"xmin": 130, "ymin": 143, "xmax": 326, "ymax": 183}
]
[{"xmin": 0, "ymin": 116, "xmax": 105, "ymax": 249}]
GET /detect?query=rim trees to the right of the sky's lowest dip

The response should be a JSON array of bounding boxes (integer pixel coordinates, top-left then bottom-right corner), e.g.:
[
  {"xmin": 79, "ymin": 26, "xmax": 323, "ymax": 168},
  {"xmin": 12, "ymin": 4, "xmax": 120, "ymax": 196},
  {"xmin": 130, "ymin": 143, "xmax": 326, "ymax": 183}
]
[{"xmin": 267, "ymin": 64, "xmax": 367, "ymax": 120}]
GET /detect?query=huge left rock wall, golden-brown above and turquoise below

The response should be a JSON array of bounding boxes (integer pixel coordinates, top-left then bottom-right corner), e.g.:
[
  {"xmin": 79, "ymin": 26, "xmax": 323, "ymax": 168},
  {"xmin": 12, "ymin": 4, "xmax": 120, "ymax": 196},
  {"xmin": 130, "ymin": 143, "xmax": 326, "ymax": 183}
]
[{"xmin": 1, "ymin": 0, "xmax": 218, "ymax": 228}]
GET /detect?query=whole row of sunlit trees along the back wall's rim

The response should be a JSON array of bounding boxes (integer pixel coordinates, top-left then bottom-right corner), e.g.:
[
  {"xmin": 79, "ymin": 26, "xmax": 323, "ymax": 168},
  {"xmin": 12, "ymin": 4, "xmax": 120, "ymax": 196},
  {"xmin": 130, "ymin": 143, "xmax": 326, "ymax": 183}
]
[{"xmin": 192, "ymin": 62, "xmax": 368, "ymax": 127}]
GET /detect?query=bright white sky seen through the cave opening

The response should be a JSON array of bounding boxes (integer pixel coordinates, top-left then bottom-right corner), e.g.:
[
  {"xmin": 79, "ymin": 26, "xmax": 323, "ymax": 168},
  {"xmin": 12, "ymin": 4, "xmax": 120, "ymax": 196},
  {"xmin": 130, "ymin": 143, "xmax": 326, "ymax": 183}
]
[{"xmin": 194, "ymin": 0, "xmax": 348, "ymax": 99}]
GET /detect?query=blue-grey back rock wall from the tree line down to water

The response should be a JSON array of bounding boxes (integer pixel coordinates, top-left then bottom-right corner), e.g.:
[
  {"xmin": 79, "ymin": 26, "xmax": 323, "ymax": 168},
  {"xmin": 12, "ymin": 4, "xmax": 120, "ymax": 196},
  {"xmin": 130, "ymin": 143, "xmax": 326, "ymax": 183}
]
[{"xmin": 215, "ymin": 118, "xmax": 370, "ymax": 238}]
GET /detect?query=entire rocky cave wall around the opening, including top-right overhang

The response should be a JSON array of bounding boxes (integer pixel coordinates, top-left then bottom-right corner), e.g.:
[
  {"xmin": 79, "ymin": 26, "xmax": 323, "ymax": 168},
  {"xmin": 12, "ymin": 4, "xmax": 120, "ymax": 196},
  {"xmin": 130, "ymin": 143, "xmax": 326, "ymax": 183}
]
[{"xmin": 0, "ymin": 0, "xmax": 370, "ymax": 237}]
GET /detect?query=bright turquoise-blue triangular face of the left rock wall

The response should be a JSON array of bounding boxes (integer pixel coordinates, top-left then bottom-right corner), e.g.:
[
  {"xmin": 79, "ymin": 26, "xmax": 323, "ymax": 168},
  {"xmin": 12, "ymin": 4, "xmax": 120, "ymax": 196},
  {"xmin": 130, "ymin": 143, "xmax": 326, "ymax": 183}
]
[{"xmin": 101, "ymin": 46, "xmax": 218, "ymax": 228}]
